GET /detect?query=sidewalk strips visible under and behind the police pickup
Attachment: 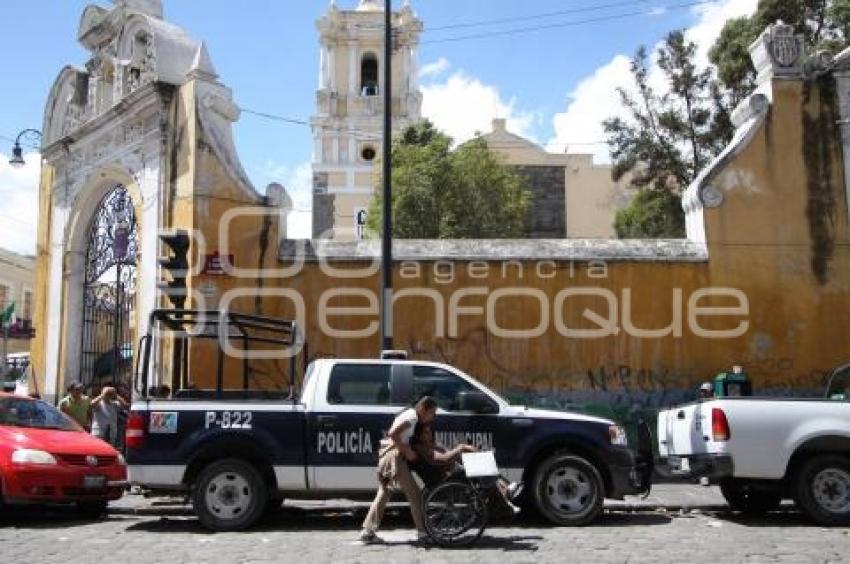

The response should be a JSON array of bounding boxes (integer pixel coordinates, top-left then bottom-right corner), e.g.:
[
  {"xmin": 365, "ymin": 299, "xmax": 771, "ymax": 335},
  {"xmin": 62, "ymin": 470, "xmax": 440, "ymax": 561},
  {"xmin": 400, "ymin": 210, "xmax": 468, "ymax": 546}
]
[{"xmin": 109, "ymin": 484, "xmax": 726, "ymax": 516}]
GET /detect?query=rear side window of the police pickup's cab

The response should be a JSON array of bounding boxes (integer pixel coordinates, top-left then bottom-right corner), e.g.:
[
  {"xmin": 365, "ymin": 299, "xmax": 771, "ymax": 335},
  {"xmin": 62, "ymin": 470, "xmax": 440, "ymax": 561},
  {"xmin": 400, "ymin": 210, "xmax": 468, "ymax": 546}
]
[{"xmin": 328, "ymin": 364, "xmax": 390, "ymax": 405}]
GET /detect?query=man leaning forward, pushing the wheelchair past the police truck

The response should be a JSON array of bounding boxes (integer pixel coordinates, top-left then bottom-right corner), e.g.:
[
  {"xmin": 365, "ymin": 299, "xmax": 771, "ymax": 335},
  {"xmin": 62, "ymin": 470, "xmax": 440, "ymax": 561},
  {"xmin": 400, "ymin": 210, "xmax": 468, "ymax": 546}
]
[{"xmin": 360, "ymin": 396, "xmax": 437, "ymax": 544}]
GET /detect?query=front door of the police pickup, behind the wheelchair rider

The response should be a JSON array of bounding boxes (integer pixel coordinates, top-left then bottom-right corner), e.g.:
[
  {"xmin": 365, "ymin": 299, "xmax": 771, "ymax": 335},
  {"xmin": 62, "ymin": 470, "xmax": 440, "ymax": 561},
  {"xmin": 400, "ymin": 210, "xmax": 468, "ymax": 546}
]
[{"xmin": 413, "ymin": 365, "xmax": 524, "ymax": 477}]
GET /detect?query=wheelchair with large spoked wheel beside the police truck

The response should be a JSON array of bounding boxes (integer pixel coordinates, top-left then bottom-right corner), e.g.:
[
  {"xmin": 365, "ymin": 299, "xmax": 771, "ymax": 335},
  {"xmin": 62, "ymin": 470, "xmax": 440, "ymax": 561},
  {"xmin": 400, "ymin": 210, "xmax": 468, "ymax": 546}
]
[{"xmin": 422, "ymin": 454, "xmax": 501, "ymax": 547}]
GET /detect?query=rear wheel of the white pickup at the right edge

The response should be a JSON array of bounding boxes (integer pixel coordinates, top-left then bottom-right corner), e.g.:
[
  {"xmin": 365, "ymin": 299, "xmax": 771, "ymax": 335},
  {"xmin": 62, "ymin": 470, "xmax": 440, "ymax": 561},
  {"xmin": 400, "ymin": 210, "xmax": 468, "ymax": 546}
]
[{"xmin": 794, "ymin": 455, "xmax": 850, "ymax": 526}]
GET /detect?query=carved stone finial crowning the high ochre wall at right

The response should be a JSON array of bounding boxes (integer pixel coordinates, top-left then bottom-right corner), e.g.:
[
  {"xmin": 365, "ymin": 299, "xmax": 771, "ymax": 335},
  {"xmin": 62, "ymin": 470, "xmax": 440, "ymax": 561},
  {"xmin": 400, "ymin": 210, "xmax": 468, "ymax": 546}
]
[{"xmin": 750, "ymin": 20, "xmax": 805, "ymax": 84}]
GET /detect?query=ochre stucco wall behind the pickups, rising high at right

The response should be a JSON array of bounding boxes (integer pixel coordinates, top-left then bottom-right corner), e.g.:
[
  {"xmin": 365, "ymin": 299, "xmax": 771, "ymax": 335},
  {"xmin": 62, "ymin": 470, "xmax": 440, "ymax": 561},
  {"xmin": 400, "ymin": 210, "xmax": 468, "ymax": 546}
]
[{"xmin": 220, "ymin": 77, "xmax": 850, "ymax": 401}]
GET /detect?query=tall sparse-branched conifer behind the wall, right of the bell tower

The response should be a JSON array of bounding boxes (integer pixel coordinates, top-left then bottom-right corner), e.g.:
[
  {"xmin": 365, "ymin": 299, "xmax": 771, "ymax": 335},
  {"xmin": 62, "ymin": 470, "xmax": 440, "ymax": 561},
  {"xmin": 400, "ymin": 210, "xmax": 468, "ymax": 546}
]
[{"xmin": 604, "ymin": 31, "xmax": 733, "ymax": 237}]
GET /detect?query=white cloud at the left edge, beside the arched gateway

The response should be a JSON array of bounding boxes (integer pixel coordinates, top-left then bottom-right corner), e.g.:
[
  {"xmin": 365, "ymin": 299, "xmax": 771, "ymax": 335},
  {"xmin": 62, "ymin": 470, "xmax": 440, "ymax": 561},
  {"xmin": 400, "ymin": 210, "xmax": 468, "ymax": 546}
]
[{"xmin": 0, "ymin": 153, "xmax": 41, "ymax": 255}]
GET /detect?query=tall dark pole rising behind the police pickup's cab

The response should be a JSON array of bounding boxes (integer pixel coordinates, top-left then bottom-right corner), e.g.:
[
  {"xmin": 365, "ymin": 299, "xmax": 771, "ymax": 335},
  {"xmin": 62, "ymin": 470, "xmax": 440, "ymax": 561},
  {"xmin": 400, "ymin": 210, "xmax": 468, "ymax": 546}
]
[{"xmin": 381, "ymin": 0, "xmax": 393, "ymax": 350}]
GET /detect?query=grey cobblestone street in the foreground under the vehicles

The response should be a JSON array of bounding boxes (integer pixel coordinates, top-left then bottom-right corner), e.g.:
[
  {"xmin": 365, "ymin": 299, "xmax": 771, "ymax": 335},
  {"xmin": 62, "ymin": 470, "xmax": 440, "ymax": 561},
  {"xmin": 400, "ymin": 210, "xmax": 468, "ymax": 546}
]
[{"xmin": 0, "ymin": 485, "xmax": 850, "ymax": 564}]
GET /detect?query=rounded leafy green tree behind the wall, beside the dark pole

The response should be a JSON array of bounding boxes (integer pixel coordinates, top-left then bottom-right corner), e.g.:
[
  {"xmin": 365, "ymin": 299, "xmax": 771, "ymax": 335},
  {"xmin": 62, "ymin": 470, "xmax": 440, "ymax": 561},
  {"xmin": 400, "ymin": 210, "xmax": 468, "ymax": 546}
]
[{"xmin": 367, "ymin": 121, "xmax": 529, "ymax": 239}]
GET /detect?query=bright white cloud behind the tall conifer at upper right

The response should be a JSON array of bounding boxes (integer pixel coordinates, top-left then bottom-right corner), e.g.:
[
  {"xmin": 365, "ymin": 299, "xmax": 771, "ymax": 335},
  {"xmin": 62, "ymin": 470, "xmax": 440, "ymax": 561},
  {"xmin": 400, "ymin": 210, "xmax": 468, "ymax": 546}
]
[{"xmin": 547, "ymin": 0, "xmax": 758, "ymax": 162}]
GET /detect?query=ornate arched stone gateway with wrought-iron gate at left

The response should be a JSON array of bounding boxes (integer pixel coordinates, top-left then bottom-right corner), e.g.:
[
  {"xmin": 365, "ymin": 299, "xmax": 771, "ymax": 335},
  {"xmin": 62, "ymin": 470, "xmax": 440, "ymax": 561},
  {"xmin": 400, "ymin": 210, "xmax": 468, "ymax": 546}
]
[{"xmin": 32, "ymin": 0, "xmax": 291, "ymax": 399}]
